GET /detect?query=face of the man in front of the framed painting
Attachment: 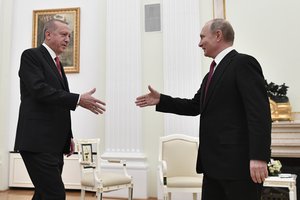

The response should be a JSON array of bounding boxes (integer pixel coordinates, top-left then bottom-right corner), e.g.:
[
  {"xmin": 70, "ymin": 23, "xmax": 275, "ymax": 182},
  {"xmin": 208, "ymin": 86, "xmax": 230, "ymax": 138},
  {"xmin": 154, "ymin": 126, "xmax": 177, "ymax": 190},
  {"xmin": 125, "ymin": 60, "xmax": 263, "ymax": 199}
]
[{"xmin": 46, "ymin": 22, "xmax": 71, "ymax": 55}]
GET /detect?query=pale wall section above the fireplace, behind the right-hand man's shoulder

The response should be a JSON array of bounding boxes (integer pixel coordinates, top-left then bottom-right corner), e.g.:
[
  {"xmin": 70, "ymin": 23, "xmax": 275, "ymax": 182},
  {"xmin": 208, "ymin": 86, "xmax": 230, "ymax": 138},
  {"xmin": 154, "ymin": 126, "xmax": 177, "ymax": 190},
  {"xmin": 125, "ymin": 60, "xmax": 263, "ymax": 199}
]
[{"xmin": 226, "ymin": 0, "xmax": 300, "ymax": 112}]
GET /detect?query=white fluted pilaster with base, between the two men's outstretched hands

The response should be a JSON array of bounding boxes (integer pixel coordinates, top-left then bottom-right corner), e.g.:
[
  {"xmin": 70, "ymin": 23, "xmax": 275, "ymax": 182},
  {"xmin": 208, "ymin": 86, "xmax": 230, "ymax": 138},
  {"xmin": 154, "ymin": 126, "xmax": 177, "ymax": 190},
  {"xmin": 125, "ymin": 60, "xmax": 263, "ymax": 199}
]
[{"xmin": 102, "ymin": 0, "xmax": 147, "ymax": 198}]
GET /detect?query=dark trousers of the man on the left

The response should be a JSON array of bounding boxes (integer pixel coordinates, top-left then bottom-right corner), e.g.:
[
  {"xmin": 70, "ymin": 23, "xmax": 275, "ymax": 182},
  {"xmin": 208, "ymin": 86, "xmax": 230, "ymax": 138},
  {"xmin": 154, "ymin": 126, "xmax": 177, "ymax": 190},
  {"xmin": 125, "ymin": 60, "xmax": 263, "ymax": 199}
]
[{"xmin": 20, "ymin": 151, "xmax": 66, "ymax": 200}]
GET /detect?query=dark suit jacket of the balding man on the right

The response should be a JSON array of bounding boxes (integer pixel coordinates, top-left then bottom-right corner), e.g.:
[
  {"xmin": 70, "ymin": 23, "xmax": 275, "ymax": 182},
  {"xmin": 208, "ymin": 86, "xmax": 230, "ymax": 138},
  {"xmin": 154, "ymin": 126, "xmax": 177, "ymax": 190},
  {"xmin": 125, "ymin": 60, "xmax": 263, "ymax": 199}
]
[{"xmin": 156, "ymin": 50, "xmax": 271, "ymax": 179}]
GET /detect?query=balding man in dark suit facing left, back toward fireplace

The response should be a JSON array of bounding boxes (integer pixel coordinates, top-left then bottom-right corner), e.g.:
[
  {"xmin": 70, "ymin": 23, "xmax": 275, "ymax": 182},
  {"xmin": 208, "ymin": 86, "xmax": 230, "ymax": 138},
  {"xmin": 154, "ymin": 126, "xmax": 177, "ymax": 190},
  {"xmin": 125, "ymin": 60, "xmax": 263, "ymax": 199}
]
[{"xmin": 136, "ymin": 19, "xmax": 271, "ymax": 200}]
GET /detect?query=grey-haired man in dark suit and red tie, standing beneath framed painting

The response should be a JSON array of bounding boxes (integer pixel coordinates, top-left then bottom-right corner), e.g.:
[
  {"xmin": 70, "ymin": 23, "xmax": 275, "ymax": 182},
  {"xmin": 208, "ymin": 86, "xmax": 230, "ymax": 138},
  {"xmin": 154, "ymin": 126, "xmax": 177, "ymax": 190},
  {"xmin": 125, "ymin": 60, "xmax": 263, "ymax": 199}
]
[{"xmin": 15, "ymin": 19, "xmax": 105, "ymax": 200}]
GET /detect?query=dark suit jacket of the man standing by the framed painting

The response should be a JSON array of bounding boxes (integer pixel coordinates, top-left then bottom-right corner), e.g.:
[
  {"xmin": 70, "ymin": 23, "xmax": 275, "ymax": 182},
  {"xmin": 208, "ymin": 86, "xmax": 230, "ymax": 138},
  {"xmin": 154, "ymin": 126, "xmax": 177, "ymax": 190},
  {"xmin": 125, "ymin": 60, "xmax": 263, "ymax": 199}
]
[{"xmin": 15, "ymin": 45, "xmax": 79, "ymax": 153}]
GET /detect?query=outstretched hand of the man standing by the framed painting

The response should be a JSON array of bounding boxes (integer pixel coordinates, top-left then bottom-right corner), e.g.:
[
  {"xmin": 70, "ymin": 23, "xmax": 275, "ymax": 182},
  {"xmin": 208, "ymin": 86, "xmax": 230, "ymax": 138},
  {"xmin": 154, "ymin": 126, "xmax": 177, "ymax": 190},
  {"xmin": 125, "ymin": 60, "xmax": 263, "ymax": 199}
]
[{"xmin": 79, "ymin": 88, "xmax": 105, "ymax": 114}]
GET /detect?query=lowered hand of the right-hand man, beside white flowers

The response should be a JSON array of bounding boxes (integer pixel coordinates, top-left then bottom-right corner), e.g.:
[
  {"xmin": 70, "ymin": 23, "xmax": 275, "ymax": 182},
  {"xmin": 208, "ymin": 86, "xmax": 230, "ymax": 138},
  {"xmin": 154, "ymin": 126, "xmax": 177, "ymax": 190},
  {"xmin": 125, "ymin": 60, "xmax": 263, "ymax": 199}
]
[{"xmin": 250, "ymin": 160, "xmax": 268, "ymax": 183}]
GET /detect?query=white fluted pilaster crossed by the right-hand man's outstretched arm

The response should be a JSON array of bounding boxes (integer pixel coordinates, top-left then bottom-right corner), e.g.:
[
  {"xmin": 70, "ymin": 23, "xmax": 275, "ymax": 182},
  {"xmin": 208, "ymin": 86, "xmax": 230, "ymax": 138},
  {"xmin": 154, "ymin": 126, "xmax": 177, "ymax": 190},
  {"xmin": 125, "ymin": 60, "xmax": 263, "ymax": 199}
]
[{"xmin": 162, "ymin": 0, "xmax": 202, "ymax": 136}]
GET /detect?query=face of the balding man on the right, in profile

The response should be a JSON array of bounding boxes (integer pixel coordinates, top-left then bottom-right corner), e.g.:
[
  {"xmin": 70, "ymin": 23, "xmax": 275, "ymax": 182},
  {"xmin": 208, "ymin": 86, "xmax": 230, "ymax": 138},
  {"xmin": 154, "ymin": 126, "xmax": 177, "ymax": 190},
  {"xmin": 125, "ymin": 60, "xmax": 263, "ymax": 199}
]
[{"xmin": 198, "ymin": 23, "xmax": 218, "ymax": 58}]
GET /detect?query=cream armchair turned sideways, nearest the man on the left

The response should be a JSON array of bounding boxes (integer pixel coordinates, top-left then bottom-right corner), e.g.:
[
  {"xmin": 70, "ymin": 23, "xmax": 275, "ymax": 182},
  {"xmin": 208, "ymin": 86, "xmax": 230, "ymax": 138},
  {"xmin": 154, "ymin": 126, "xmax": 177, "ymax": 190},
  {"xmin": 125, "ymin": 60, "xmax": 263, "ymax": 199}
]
[{"xmin": 76, "ymin": 139, "xmax": 133, "ymax": 200}]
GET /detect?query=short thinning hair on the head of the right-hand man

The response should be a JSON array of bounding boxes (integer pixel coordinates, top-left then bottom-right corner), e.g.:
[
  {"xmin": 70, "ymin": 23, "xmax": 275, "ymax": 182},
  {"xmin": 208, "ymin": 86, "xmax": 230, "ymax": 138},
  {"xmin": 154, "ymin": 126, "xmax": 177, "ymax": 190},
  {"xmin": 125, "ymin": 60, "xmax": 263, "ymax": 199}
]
[{"xmin": 210, "ymin": 18, "xmax": 234, "ymax": 43}]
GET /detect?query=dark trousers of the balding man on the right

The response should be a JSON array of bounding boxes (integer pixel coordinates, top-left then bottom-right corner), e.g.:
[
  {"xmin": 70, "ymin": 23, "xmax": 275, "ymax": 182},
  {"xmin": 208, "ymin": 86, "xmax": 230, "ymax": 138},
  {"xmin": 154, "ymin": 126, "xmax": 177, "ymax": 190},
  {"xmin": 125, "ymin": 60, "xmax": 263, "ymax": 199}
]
[{"xmin": 202, "ymin": 175, "xmax": 263, "ymax": 200}]
